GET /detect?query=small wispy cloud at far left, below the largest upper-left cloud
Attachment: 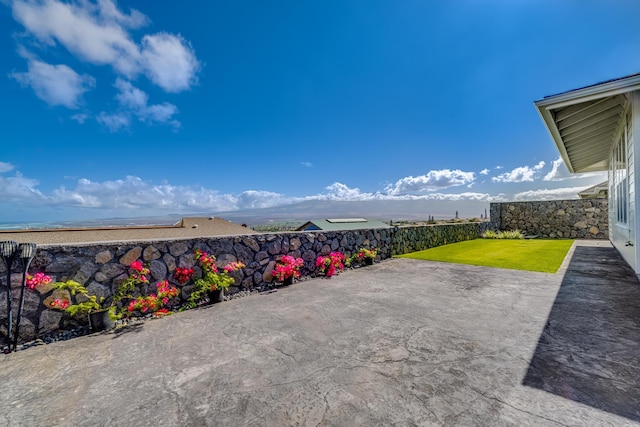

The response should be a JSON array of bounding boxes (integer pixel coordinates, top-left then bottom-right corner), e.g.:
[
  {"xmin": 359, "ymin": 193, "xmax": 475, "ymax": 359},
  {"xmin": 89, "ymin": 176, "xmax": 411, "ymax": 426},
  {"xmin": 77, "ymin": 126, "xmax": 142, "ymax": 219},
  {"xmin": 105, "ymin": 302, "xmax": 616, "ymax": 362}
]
[{"xmin": 11, "ymin": 59, "xmax": 95, "ymax": 109}]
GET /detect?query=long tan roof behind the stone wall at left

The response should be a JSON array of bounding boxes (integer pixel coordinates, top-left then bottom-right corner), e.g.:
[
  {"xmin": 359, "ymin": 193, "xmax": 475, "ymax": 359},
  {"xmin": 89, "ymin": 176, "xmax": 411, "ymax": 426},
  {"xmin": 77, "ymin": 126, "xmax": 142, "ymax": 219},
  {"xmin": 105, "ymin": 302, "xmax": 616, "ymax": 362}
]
[{"xmin": 0, "ymin": 217, "xmax": 257, "ymax": 245}]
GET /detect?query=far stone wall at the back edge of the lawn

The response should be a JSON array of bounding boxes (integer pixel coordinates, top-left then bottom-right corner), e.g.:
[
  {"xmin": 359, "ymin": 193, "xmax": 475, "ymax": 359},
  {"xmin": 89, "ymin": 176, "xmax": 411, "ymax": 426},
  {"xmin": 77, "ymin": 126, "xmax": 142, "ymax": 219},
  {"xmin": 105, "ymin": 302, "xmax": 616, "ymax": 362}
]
[{"xmin": 490, "ymin": 199, "xmax": 609, "ymax": 239}]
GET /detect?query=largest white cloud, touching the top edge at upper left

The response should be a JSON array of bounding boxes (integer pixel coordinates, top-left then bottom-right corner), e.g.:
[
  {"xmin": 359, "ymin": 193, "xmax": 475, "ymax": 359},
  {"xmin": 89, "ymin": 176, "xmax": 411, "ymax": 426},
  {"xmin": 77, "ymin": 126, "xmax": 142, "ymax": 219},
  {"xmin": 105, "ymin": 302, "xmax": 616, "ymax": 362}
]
[{"xmin": 13, "ymin": 0, "xmax": 200, "ymax": 92}]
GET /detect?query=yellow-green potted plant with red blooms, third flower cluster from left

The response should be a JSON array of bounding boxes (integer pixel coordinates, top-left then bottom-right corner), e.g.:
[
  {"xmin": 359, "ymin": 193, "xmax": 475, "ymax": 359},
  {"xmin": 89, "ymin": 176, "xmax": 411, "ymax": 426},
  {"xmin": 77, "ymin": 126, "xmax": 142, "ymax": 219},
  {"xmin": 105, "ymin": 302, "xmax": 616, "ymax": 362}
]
[{"xmin": 185, "ymin": 249, "xmax": 246, "ymax": 308}]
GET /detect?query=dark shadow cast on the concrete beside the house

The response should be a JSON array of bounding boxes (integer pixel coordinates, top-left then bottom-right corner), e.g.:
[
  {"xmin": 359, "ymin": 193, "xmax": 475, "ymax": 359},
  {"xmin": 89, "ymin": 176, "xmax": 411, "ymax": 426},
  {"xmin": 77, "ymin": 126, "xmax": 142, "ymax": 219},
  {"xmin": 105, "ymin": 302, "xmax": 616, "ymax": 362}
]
[{"xmin": 523, "ymin": 246, "xmax": 640, "ymax": 421}]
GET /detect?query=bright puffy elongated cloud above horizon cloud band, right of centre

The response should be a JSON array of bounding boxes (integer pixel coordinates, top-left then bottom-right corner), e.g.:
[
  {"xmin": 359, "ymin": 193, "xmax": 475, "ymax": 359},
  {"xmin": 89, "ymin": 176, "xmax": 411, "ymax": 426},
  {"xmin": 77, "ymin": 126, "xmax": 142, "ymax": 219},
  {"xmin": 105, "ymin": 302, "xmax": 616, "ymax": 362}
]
[{"xmin": 386, "ymin": 169, "xmax": 475, "ymax": 195}]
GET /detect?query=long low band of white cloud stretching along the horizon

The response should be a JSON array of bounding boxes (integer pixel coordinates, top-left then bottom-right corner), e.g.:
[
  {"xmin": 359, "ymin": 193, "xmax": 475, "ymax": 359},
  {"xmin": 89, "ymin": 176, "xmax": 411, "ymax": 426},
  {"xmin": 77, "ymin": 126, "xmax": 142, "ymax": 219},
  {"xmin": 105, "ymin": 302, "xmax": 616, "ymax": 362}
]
[{"xmin": 0, "ymin": 164, "xmax": 600, "ymax": 219}]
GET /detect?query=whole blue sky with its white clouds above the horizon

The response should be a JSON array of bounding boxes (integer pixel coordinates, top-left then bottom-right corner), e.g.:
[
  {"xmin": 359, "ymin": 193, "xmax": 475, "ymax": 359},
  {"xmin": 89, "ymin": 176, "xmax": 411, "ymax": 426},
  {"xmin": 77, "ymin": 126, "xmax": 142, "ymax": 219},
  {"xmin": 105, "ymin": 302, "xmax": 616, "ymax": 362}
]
[{"xmin": 0, "ymin": 0, "xmax": 640, "ymax": 221}]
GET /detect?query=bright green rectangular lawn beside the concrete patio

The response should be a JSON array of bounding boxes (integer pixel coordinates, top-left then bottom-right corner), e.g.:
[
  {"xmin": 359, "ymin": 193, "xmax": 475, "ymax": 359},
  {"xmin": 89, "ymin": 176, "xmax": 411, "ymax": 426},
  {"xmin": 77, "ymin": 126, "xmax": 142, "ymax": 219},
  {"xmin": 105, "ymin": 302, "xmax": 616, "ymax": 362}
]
[{"xmin": 399, "ymin": 239, "xmax": 573, "ymax": 273}]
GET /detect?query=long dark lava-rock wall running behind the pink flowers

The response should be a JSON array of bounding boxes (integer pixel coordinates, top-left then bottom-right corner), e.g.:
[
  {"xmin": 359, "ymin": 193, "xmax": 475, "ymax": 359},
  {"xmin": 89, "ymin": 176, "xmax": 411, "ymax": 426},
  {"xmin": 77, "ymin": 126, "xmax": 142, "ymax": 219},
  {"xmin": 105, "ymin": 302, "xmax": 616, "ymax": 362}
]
[{"xmin": 0, "ymin": 223, "xmax": 487, "ymax": 340}]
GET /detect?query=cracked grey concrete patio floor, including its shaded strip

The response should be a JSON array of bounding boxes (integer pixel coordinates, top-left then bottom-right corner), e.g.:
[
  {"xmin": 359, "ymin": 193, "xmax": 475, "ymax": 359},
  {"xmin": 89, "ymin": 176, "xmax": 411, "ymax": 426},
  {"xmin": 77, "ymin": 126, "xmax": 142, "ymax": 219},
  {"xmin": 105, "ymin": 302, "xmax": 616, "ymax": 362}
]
[{"xmin": 0, "ymin": 241, "xmax": 640, "ymax": 426}]
